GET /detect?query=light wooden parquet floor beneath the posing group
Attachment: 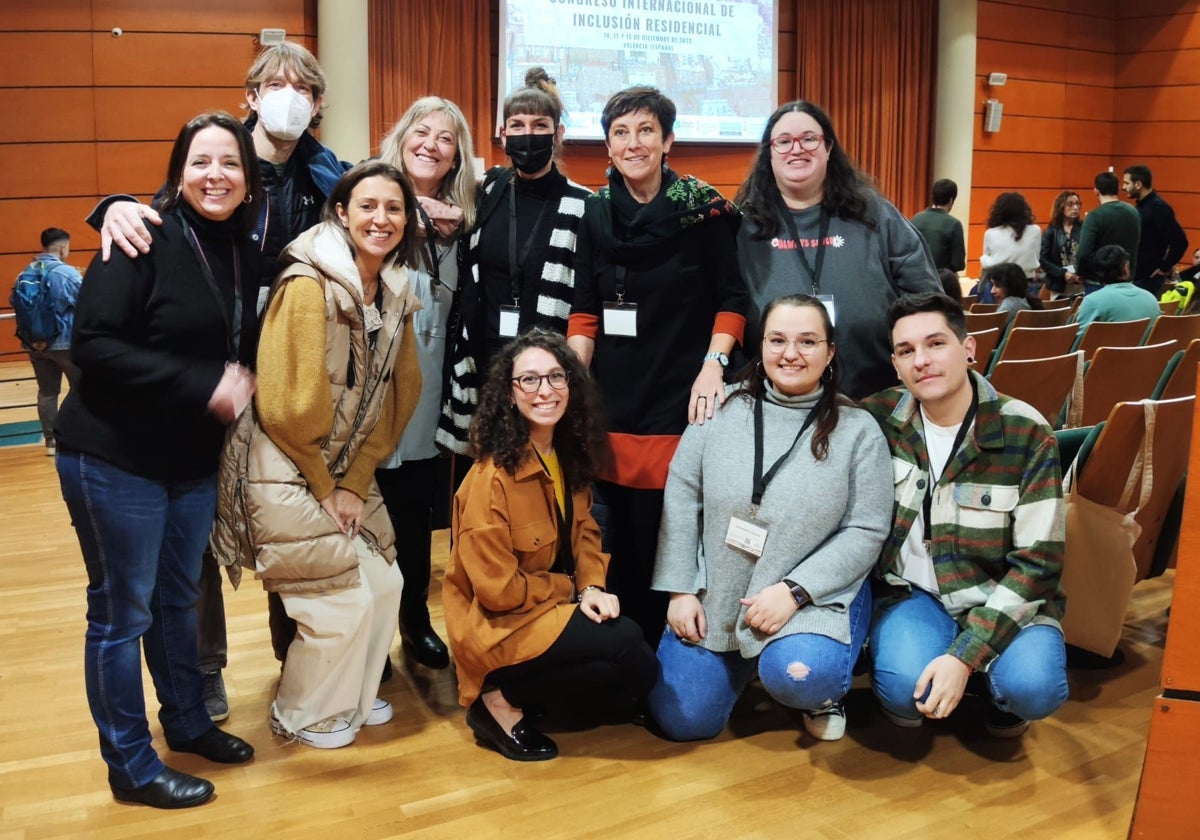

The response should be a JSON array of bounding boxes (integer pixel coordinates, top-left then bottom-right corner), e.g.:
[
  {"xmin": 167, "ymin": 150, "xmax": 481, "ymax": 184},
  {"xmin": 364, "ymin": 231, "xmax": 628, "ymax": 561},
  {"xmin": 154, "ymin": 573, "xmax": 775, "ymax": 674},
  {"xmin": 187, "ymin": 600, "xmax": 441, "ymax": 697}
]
[{"xmin": 0, "ymin": 446, "xmax": 1187, "ymax": 840}]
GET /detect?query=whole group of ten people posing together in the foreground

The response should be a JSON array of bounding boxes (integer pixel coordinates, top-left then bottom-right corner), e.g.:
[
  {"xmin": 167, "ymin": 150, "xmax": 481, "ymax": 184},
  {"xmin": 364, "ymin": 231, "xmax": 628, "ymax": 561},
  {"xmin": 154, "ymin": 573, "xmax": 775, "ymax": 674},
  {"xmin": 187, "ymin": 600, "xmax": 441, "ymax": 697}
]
[{"xmin": 55, "ymin": 43, "xmax": 1067, "ymax": 808}]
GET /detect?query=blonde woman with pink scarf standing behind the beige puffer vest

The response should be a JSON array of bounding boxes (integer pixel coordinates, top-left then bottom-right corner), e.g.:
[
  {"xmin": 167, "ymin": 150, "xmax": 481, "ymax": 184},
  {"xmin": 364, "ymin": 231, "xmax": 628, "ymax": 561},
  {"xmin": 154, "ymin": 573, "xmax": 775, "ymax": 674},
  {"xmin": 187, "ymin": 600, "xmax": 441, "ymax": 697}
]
[{"xmin": 376, "ymin": 96, "xmax": 476, "ymax": 679}]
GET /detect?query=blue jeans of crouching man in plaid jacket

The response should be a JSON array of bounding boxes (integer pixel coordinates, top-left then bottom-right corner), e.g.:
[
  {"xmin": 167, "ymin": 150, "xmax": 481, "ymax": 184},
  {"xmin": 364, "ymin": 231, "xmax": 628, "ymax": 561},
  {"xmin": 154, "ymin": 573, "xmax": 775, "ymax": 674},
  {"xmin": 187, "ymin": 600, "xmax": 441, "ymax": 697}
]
[{"xmin": 870, "ymin": 589, "xmax": 1068, "ymax": 720}]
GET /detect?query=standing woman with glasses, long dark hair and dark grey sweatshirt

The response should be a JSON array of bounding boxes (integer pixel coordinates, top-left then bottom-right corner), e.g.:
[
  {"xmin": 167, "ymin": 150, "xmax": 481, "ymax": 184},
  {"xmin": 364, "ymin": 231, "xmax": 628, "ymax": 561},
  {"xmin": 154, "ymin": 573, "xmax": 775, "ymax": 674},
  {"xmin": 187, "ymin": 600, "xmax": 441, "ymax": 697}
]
[{"xmin": 736, "ymin": 100, "xmax": 941, "ymax": 398}]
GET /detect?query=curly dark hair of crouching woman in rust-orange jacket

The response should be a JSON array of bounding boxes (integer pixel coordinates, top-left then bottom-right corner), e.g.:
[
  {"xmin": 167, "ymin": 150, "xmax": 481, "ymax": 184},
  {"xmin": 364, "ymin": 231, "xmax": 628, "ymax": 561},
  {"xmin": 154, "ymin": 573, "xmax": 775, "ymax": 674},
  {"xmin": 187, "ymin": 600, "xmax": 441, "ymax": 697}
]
[{"xmin": 468, "ymin": 326, "xmax": 611, "ymax": 491}]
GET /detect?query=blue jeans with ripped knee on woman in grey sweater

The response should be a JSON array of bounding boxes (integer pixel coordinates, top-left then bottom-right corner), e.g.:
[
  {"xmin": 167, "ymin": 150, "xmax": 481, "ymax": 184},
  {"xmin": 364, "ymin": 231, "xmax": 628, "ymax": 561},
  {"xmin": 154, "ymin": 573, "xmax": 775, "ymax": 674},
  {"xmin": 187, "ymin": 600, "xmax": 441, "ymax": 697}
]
[{"xmin": 649, "ymin": 584, "xmax": 871, "ymax": 740}]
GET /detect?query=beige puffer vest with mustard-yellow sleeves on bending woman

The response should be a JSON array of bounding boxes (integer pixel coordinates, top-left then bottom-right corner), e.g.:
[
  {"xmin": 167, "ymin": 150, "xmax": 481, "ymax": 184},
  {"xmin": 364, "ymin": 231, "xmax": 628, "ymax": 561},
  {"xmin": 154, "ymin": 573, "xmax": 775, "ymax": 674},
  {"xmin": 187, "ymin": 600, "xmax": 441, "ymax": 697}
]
[{"xmin": 212, "ymin": 219, "xmax": 421, "ymax": 593}]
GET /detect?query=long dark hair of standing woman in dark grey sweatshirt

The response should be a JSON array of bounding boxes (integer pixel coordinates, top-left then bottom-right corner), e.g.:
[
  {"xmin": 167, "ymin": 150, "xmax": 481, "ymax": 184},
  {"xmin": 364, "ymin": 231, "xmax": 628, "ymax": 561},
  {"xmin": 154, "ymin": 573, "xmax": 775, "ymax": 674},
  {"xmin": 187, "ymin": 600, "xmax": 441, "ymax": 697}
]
[{"xmin": 733, "ymin": 100, "xmax": 876, "ymax": 239}]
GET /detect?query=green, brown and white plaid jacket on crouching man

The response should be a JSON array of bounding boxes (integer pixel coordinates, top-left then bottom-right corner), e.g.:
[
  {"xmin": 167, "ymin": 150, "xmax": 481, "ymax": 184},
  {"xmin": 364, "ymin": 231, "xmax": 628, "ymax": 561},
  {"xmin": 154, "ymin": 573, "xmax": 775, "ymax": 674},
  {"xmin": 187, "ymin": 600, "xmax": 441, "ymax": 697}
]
[{"xmin": 863, "ymin": 372, "xmax": 1066, "ymax": 670}]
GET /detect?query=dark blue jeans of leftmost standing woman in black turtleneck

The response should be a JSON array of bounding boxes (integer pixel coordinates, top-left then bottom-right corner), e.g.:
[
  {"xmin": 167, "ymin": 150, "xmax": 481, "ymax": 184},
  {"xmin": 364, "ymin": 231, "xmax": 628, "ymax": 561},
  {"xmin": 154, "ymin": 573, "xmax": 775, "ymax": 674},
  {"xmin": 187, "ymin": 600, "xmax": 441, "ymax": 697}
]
[{"xmin": 58, "ymin": 451, "xmax": 216, "ymax": 787}]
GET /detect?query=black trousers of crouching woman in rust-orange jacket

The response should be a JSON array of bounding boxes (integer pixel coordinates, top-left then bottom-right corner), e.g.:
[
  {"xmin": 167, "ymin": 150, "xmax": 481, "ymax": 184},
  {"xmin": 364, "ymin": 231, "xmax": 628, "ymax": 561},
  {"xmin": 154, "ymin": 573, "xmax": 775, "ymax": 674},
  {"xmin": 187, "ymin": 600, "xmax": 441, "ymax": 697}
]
[{"xmin": 484, "ymin": 610, "xmax": 659, "ymax": 709}]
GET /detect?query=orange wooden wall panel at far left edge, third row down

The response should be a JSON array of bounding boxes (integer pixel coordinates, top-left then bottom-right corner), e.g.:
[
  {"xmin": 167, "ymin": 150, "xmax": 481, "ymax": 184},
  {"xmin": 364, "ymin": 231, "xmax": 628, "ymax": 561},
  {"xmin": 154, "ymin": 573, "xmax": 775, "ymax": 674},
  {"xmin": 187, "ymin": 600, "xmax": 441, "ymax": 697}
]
[{"xmin": 0, "ymin": 88, "xmax": 96, "ymax": 143}]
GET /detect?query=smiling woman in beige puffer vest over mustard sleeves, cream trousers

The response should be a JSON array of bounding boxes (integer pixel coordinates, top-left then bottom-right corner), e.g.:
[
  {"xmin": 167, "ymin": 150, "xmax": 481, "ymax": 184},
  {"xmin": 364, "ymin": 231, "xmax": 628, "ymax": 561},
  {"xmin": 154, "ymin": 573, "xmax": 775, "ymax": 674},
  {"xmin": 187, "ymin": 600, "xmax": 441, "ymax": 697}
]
[{"xmin": 214, "ymin": 161, "xmax": 421, "ymax": 749}]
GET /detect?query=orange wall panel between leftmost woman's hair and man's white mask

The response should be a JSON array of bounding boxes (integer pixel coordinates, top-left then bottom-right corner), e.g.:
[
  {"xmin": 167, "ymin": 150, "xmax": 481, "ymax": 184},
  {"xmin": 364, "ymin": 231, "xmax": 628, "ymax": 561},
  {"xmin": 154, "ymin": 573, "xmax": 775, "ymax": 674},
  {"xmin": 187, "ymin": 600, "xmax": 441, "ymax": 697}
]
[{"xmin": 96, "ymin": 86, "xmax": 246, "ymax": 140}]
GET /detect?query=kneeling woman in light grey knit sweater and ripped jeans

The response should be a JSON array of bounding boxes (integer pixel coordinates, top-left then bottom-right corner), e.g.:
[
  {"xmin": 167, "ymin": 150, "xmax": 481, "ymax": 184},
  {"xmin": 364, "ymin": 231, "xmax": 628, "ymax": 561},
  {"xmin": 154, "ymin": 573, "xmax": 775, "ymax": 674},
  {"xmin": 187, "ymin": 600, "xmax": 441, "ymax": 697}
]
[{"xmin": 649, "ymin": 295, "xmax": 893, "ymax": 740}]
